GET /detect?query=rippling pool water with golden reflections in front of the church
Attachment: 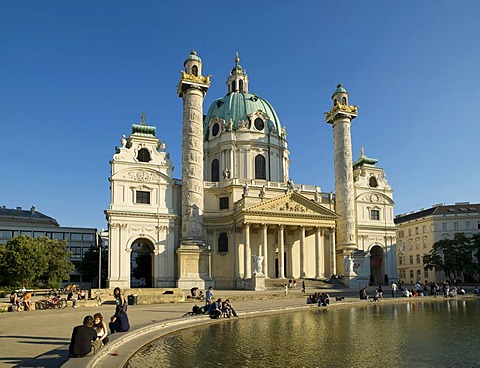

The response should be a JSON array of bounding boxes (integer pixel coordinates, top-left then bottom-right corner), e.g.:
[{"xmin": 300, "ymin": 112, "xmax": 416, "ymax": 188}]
[{"xmin": 127, "ymin": 298, "xmax": 480, "ymax": 368}]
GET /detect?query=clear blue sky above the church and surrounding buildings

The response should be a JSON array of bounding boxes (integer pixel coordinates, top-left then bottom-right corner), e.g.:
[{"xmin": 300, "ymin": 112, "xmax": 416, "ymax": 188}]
[{"xmin": 0, "ymin": 0, "xmax": 480, "ymax": 229}]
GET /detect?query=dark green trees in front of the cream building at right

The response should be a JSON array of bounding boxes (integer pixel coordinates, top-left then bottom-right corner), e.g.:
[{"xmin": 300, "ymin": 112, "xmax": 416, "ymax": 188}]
[{"xmin": 423, "ymin": 233, "xmax": 480, "ymax": 281}]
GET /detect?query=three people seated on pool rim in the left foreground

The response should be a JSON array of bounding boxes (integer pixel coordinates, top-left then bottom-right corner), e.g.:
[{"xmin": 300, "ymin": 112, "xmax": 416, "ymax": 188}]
[{"xmin": 68, "ymin": 287, "xmax": 130, "ymax": 358}]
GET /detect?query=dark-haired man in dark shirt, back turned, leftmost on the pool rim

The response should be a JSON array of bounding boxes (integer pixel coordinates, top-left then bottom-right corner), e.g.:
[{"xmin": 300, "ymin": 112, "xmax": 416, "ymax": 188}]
[{"xmin": 68, "ymin": 316, "xmax": 102, "ymax": 358}]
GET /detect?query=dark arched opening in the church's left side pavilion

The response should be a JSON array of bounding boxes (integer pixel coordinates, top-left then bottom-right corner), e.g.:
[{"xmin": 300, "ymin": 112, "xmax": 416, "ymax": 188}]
[{"xmin": 130, "ymin": 239, "xmax": 154, "ymax": 288}]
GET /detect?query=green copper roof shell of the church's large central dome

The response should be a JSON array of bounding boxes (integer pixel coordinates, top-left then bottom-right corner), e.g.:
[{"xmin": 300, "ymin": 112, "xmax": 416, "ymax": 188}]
[{"xmin": 203, "ymin": 92, "xmax": 282, "ymax": 138}]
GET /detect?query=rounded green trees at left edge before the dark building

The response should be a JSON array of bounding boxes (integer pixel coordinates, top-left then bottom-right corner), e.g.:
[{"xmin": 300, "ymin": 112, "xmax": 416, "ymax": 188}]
[{"xmin": 0, "ymin": 235, "xmax": 73, "ymax": 287}]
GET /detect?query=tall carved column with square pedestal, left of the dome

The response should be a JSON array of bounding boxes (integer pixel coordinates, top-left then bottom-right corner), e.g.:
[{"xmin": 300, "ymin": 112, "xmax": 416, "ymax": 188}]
[{"xmin": 177, "ymin": 51, "xmax": 211, "ymax": 288}]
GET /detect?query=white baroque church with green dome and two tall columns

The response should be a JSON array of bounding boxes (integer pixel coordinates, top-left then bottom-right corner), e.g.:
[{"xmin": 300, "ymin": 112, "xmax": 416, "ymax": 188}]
[{"xmin": 105, "ymin": 51, "xmax": 397, "ymax": 290}]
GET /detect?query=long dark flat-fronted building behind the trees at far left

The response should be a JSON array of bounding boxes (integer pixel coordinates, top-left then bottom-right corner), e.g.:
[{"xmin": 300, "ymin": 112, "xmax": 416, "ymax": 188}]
[{"xmin": 0, "ymin": 206, "xmax": 102, "ymax": 288}]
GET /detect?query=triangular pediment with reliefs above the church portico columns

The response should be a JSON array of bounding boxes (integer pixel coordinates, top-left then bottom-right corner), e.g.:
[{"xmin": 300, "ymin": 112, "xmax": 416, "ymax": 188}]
[{"xmin": 243, "ymin": 192, "xmax": 339, "ymax": 219}]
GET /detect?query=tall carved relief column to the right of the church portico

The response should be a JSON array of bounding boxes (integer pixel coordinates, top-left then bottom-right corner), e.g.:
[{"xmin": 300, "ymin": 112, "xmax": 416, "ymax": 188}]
[{"xmin": 325, "ymin": 84, "xmax": 357, "ymax": 283}]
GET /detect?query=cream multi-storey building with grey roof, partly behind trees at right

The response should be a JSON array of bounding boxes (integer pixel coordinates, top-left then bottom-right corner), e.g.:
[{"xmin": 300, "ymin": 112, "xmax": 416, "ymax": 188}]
[{"xmin": 395, "ymin": 202, "xmax": 480, "ymax": 283}]
